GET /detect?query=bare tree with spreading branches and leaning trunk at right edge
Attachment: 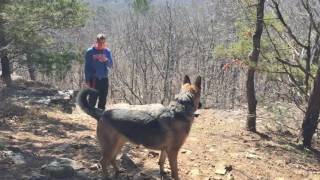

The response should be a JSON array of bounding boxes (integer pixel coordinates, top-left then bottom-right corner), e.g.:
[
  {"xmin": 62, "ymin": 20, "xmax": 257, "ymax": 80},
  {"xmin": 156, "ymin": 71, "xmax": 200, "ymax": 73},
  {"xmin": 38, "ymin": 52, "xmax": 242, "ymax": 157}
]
[{"xmin": 269, "ymin": 0, "xmax": 320, "ymax": 148}]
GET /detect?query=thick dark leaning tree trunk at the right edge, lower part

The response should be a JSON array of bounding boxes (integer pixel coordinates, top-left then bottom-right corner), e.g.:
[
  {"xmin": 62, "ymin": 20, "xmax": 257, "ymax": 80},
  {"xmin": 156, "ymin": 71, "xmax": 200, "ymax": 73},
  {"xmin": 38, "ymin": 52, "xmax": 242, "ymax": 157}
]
[{"xmin": 302, "ymin": 67, "xmax": 320, "ymax": 148}]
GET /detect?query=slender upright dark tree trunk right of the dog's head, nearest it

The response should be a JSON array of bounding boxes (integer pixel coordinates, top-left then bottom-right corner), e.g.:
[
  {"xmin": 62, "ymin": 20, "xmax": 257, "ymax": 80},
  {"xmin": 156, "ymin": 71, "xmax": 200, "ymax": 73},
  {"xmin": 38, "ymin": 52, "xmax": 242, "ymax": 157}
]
[{"xmin": 247, "ymin": 0, "xmax": 265, "ymax": 132}]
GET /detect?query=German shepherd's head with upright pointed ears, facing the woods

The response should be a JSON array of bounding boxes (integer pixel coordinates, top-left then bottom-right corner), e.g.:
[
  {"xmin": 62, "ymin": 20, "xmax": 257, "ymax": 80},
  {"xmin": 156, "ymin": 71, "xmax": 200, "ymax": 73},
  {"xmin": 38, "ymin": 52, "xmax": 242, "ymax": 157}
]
[{"xmin": 181, "ymin": 75, "xmax": 201, "ymax": 111}]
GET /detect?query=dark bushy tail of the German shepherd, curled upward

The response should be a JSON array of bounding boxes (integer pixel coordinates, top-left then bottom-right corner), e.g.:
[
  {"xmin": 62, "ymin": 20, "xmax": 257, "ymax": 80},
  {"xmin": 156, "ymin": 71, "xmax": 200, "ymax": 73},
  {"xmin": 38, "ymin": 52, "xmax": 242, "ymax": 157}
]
[{"xmin": 77, "ymin": 88, "xmax": 103, "ymax": 121}]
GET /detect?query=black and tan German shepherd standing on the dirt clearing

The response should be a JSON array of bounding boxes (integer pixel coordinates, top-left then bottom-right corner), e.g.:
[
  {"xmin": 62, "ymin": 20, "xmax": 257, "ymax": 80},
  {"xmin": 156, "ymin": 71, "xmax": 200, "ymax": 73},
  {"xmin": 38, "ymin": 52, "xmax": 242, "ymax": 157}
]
[{"xmin": 77, "ymin": 76, "xmax": 201, "ymax": 180}]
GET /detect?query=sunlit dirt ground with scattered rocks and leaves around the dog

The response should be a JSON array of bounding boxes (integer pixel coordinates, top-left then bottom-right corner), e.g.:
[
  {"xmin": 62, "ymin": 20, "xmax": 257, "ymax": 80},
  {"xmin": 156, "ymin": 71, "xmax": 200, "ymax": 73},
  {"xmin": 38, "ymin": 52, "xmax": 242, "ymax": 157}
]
[{"xmin": 0, "ymin": 81, "xmax": 320, "ymax": 180}]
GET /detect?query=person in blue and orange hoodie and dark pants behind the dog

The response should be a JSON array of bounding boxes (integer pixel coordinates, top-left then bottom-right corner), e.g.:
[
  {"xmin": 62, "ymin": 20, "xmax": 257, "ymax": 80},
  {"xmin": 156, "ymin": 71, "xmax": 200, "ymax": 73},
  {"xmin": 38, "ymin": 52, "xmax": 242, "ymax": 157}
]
[{"xmin": 84, "ymin": 34, "xmax": 113, "ymax": 109}]
